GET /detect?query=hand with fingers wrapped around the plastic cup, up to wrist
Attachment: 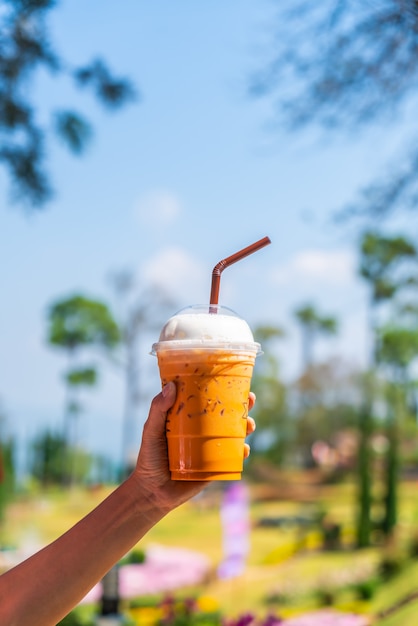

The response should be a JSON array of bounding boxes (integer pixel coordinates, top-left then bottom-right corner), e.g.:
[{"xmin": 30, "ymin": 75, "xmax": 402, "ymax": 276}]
[{"xmin": 134, "ymin": 382, "xmax": 255, "ymax": 512}]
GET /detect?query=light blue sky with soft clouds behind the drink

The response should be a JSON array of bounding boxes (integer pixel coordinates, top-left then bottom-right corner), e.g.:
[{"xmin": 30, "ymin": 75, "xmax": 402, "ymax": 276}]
[{"xmin": 0, "ymin": 0, "xmax": 404, "ymax": 468}]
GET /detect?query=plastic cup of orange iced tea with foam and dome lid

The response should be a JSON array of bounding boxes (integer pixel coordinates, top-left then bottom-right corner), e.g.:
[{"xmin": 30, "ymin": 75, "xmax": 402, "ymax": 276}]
[{"xmin": 152, "ymin": 305, "xmax": 260, "ymax": 481}]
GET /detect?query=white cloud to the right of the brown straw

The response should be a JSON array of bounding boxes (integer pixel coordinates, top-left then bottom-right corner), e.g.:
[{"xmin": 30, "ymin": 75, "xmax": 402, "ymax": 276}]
[{"xmin": 272, "ymin": 250, "xmax": 356, "ymax": 286}]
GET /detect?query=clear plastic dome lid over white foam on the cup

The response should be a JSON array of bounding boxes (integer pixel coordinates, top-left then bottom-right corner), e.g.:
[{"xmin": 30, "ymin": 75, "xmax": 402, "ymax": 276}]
[{"xmin": 151, "ymin": 304, "xmax": 261, "ymax": 354}]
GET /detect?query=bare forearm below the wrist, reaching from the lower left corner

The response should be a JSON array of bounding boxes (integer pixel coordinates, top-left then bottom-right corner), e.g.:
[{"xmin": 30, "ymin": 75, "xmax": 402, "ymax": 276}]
[{"xmin": 0, "ymin": 477, "xmax": 167, "ymax": 626}]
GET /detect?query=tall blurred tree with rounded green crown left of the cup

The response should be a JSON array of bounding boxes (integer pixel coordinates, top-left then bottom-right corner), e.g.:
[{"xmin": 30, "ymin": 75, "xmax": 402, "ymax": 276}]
[{"xmin": 47, "ymin": 295, "xmax": 121, "ymax": 481}]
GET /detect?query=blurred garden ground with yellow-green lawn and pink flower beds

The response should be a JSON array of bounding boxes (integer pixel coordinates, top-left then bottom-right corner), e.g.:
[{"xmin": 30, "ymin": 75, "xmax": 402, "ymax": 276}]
[{"xmin": 4, "ymin": 472, "xmax": 408, "ymax": 626}]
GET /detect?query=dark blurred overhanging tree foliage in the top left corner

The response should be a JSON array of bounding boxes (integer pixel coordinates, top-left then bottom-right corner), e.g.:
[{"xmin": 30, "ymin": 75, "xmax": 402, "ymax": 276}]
[{"xmin": 0, "ymin": 0, "xmax": 135, "ymax": 207}]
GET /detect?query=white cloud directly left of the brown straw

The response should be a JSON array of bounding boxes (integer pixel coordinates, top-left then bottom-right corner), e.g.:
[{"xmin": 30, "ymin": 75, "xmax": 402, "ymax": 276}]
[{"xmin": 141, "ymin": 247, "xmax": 210, "ymax": 306}]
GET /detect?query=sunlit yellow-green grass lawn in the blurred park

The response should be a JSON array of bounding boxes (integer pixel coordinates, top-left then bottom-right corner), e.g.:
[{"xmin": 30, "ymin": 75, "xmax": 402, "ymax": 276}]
[{"xmin": 3, "ymin": 483, "xmax": 418, "ymax": 626}]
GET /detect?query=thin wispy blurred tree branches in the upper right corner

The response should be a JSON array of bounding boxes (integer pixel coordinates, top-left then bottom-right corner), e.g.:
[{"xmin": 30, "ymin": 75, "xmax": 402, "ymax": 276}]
[{"xmin": 249, "ymin": 0, "xmax": 418, "ymax": 216}]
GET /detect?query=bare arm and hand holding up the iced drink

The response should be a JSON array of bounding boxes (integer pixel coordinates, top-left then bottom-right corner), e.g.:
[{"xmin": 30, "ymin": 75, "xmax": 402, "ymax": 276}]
[{"xmin": 0, "ymin": 383, "xmax": 254, "ymax": 626}]
